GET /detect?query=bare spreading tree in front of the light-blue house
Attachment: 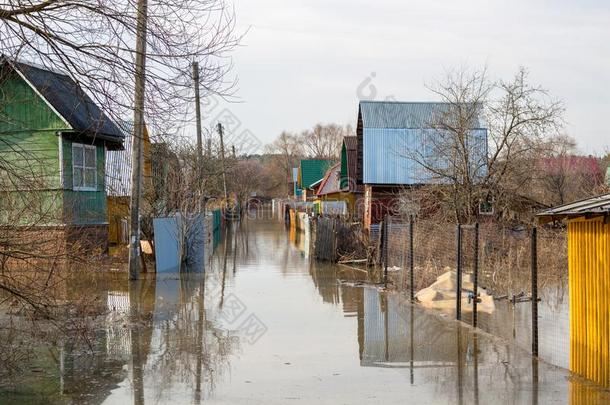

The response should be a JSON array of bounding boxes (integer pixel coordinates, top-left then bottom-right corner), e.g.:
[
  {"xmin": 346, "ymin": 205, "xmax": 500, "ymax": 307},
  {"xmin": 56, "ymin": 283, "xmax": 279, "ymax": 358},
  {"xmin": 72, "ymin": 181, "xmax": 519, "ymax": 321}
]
[{"xmin": 405, "ymin": 68, "xmax": 564, "ymax": 222}]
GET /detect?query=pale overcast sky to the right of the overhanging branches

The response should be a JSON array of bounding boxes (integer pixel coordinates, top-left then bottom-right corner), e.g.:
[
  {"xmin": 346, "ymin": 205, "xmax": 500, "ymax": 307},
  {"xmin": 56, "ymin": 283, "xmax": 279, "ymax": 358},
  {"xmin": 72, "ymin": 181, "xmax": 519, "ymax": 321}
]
[{"xmin": 206, "ymin": 0, "xmax": 610, "ymax": 154}]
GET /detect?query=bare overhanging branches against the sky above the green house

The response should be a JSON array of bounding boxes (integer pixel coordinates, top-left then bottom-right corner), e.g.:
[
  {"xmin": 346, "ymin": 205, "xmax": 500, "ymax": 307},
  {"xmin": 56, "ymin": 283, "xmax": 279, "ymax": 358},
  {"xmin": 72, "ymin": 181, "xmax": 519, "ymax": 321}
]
[{"xmin": 0, "ymin": 0, "xmax": 239, "ymax": 134}]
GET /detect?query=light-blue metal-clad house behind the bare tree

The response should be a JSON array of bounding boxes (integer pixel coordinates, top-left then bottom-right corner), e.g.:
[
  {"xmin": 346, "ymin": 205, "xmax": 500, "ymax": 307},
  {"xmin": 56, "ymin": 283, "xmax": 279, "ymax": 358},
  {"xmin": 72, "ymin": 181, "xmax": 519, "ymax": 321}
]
[{"xmin": 356, "ymin": 101, "xmax": 487, "ymax": 229}]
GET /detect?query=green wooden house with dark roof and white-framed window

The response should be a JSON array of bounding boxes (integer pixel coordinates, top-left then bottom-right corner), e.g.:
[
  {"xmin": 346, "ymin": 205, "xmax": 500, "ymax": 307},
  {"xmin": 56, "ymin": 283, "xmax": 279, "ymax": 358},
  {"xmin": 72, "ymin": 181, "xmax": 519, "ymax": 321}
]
[{"xmin": 0, "ymin": 58, "xmax": 124, "ymax": 249}]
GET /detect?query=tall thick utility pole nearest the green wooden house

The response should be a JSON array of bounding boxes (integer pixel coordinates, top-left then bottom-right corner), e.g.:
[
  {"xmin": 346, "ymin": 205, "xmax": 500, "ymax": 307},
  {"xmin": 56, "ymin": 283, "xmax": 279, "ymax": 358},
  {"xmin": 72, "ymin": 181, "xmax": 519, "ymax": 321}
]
[{"xmin": 129, "ymin": 0, "xmax": 148, "ymax": 280}]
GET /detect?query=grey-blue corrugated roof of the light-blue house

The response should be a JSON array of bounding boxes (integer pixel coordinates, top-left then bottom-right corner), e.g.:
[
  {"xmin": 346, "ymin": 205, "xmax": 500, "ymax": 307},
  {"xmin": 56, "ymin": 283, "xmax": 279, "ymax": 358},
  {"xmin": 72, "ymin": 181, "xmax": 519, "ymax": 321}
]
[{"xmin": 360, "ymin": 101, "xmax": 483, "ymax": 129}]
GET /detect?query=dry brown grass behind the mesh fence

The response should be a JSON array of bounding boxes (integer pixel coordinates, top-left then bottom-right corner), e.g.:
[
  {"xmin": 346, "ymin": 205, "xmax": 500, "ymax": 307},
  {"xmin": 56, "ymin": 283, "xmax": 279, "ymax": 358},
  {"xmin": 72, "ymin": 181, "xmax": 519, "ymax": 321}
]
[{"xmin": 388, "ymin": 220, "xmax": 567, "ymax": 296}]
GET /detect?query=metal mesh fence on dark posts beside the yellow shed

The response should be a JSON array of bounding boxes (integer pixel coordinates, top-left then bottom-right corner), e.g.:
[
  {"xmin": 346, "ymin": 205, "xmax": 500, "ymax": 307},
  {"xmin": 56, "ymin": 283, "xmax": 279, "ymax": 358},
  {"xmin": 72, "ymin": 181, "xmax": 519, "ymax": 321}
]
[{"xmin": 384, "ymin": 218, "xmax": 570, "ymax": 368}]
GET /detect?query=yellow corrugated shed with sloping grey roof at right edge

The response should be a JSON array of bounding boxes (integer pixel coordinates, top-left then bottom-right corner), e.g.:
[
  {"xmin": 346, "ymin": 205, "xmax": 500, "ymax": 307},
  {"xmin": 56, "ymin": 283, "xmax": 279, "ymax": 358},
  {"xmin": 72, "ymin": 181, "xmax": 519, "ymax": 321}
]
[{"xmin": 538, "ymin": 194, "xmax": 610, "ymax": 387}]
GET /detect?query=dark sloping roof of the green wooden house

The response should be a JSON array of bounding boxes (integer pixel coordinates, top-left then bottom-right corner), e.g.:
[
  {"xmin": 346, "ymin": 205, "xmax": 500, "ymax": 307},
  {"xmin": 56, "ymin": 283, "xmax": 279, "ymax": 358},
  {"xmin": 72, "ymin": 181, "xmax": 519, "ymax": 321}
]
[{"xmin": 7, "ymin": 60, "xmax": 124, "ymax": 143}]
